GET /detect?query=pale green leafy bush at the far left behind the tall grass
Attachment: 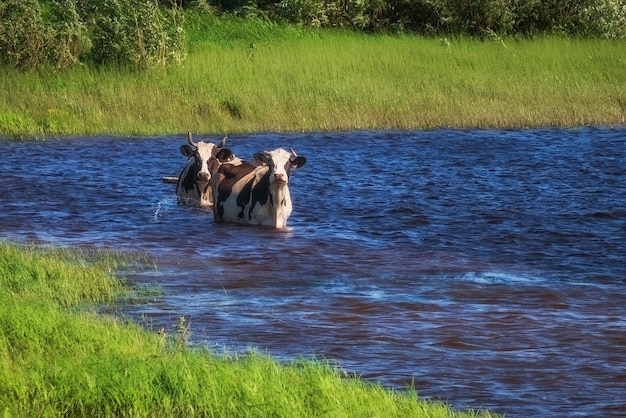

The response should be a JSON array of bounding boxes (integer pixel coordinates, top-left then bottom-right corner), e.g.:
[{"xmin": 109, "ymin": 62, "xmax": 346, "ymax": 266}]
[{"xmin": 0, "ymin": 0, "xmax": 185, "ymax": 70}]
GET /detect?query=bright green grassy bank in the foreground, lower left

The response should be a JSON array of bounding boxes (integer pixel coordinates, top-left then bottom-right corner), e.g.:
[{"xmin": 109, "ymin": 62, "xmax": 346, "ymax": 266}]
[{"xmin": 0, "ymin": 243, "xmax": 498, "ymax": 417}]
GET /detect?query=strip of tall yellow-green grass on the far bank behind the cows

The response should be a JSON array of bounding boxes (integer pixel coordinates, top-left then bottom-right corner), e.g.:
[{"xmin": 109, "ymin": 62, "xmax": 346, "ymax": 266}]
[{"xmin": 0, "ymin": 18, "xmax": 626, "ymax": 136}]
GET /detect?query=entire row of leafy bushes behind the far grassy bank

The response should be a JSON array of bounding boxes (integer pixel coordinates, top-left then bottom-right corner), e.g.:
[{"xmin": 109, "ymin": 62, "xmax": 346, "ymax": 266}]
[{"xmin": 0, "ymin": 0, "xmax": 626, "ymax": 70}]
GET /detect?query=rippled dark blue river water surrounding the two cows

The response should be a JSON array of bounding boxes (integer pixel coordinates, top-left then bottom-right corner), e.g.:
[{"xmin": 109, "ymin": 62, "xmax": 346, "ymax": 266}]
[{"xmin": 0, "ymin": 128, "xmax": 626, "ymax": 417}]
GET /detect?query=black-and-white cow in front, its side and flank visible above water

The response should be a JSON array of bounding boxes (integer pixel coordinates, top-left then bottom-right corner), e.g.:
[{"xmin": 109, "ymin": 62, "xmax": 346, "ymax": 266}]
[{"xmin": 211, "ymin": 148, "xmax": 306, "ymax": 229}]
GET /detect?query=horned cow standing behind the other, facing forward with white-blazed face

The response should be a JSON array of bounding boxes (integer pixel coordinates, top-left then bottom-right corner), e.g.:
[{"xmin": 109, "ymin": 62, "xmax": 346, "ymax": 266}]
[{"xmin": 176, "ymin": 132, "xmax": 234, "ymax": 206}]
